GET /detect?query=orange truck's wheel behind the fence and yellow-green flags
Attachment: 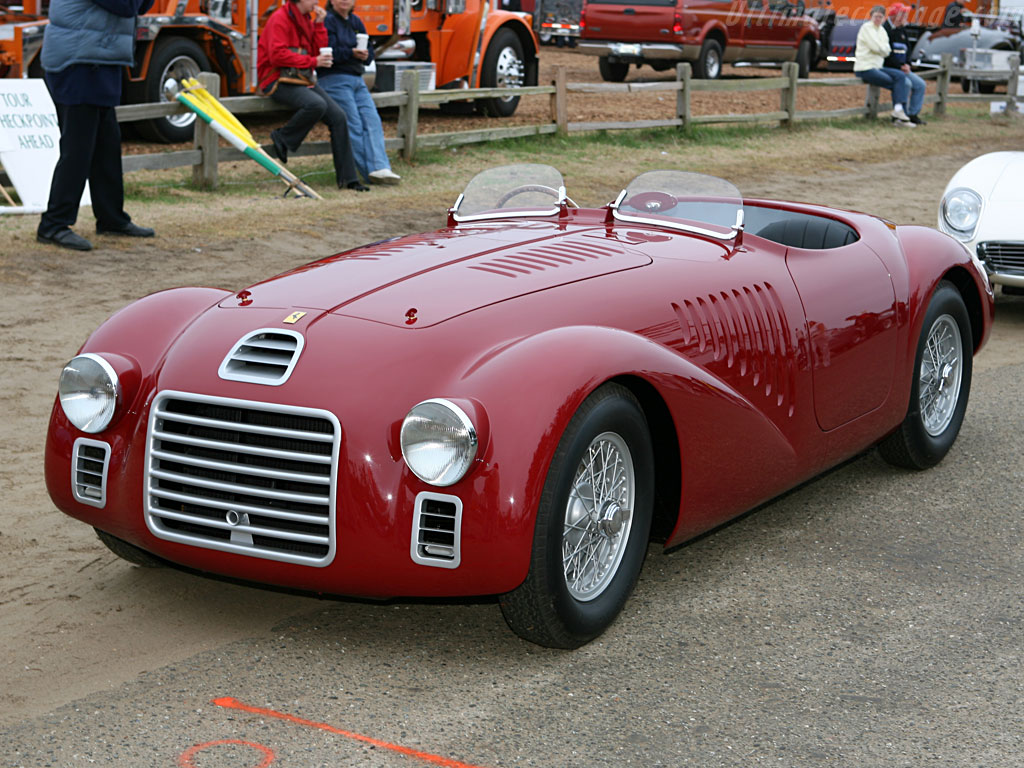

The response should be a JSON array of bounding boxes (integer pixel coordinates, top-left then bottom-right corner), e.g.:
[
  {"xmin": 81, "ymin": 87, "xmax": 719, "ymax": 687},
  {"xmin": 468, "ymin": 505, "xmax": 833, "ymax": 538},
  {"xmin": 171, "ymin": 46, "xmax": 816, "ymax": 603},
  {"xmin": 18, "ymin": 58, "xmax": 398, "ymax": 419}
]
[{"xmin": 132, "ymin": 37, "xmax": 210, "ymax": 144}]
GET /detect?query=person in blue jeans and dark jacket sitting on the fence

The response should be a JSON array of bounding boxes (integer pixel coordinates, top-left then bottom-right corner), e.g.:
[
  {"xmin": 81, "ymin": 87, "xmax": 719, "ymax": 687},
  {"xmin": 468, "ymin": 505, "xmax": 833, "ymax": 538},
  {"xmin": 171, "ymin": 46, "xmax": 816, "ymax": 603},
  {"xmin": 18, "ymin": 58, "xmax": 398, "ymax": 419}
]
[{"xmin": 316, "ymin": 0, "xmax": 401, "ymax": 184}]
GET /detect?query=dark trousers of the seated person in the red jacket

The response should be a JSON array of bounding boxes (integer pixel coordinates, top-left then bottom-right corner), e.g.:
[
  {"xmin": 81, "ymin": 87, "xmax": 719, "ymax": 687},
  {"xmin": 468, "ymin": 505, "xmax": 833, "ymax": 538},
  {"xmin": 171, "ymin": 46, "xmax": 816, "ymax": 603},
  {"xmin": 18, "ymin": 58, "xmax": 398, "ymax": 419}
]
[{"xmin": 270, "ymin": 83, "xmax": 359, "ymax": 186}]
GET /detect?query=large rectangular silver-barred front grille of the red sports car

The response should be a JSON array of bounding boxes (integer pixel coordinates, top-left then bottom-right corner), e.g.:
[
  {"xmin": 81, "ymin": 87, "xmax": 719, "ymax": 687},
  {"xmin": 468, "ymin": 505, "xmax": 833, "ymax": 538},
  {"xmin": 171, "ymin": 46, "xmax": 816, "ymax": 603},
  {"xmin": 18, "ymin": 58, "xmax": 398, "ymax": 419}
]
[{"xmin": 146, "ymin": 391, "xmax": 341, "ymax": 566}]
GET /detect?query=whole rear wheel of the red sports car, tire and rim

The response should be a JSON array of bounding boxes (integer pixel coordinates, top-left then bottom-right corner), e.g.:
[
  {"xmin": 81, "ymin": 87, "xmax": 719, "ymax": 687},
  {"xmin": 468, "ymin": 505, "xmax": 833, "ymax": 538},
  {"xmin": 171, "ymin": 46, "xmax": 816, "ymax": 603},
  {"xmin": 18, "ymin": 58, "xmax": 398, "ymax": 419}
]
[{"xmin": 879, "ymin": 281, "xmax": 974, "ymax": 469}]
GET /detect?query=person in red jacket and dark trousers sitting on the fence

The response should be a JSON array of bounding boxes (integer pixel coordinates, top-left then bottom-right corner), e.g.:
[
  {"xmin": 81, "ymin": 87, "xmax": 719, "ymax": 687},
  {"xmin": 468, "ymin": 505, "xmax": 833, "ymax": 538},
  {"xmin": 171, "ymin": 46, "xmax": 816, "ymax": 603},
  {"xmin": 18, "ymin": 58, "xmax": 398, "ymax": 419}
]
[{"xmin": 257, "ymin": 0, "xmax": 370, "ymax": 191}]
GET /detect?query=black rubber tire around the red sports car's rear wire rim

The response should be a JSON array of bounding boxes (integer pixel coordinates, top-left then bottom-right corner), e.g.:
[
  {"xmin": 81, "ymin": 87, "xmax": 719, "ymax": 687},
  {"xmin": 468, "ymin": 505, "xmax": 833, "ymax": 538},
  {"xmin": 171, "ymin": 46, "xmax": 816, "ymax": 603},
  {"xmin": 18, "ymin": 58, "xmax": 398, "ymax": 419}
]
[{"xmin": 904, "ymin": 283, "xmax": 974, "ymax": 466}]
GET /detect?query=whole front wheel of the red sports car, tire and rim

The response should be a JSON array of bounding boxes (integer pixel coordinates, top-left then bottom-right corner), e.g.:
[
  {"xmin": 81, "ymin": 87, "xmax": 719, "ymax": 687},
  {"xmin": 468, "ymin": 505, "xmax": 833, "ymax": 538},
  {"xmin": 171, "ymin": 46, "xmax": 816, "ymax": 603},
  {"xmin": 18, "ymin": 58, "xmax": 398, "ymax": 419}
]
[{"xmin": 500, "ymin": 384, "xmax": 654, "ymax": 648}]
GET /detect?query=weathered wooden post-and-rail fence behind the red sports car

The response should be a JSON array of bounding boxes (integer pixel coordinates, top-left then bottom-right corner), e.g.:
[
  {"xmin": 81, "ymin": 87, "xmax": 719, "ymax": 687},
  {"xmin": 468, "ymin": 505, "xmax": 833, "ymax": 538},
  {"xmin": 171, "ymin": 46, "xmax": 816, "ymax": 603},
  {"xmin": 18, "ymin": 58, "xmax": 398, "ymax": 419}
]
[{"xmin": 117, "ymin": 54, "xmax": 1020, "ymax": 188}]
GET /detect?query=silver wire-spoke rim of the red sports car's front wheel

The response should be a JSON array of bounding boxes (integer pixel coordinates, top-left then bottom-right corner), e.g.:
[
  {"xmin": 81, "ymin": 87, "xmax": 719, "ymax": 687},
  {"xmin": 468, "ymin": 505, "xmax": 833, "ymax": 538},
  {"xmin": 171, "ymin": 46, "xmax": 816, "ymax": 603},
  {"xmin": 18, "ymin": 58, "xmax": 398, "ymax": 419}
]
[{"xmin": 562, "ymin": 432, "xmax": 636, "ymax": 601}]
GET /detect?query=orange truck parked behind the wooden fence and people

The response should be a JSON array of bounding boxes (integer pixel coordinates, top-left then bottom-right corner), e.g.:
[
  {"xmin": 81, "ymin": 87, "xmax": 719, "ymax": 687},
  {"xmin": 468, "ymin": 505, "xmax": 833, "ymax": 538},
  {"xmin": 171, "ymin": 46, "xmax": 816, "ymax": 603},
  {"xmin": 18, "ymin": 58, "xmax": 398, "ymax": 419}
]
[{"xmin": 0, "ymin": 0, "xmax": 538, "ymax": 142}]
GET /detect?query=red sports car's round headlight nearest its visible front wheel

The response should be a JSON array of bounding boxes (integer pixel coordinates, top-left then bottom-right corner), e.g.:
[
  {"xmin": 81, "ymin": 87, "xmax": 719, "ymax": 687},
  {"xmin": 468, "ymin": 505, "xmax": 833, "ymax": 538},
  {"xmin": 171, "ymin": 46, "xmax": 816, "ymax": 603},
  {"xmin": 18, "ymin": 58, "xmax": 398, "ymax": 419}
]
[{"xmin": 401, "ymin": 399, "xmax": 477, "ymax": 485}]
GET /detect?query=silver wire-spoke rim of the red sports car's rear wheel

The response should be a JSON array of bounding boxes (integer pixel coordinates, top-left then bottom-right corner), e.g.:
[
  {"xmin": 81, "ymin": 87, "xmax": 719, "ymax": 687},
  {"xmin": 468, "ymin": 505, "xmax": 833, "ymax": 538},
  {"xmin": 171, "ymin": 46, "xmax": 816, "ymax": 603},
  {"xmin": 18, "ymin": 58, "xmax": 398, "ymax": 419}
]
[{"xmin": 918, "ymin": 314, "xmax": 964, "ymax": 437}]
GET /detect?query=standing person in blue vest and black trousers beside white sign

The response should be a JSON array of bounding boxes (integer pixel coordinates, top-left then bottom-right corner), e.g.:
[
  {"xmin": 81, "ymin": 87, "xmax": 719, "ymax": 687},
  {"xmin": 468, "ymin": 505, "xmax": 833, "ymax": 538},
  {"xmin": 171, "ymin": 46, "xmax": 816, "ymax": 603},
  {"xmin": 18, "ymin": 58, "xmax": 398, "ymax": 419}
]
[{"xmin": 36, "ymin": 0, "xmax": 154, "ymax": 251}]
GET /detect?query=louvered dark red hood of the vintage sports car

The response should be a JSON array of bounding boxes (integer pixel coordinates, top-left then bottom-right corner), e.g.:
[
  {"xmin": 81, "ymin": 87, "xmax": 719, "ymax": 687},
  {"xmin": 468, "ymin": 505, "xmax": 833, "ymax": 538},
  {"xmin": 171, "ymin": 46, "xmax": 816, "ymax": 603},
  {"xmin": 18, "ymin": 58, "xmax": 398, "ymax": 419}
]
[{"xmin": 220, "ymin": 222, "xmax": 651, "ymax": 328}]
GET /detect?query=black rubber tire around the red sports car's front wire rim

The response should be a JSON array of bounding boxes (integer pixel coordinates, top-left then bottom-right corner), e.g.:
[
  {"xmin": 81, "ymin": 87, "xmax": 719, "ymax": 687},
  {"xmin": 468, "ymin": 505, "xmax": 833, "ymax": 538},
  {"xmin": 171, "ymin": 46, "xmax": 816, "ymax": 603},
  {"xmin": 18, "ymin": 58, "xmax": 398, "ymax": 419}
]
[{"xmin": 538, "ymin": 390, "xmax": 654, "ymax": 641}]
